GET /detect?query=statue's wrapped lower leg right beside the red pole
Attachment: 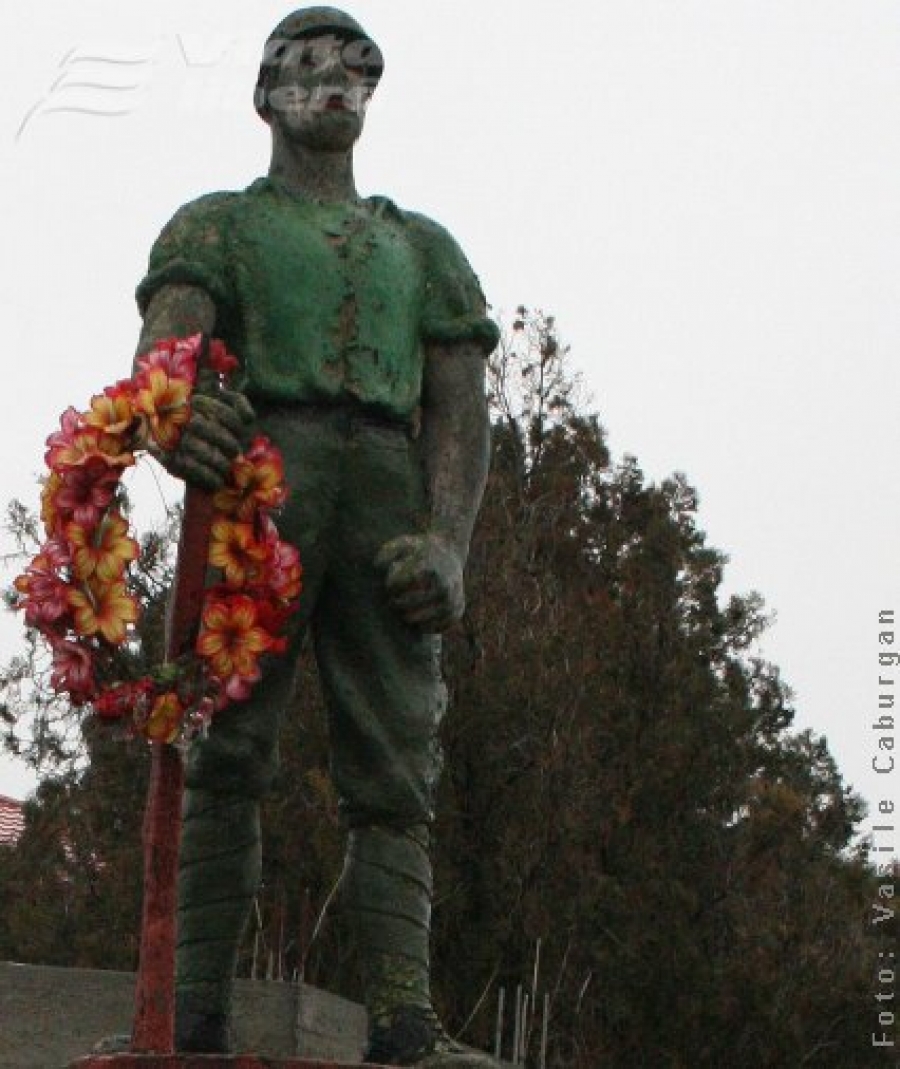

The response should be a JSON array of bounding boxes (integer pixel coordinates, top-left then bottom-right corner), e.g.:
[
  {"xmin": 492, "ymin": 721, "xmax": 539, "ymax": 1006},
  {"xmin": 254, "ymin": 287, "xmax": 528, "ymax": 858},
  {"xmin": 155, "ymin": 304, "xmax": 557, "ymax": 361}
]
[{"xmin": 175, "ymin": 788, "xmax": 260, "ymax": 1054}]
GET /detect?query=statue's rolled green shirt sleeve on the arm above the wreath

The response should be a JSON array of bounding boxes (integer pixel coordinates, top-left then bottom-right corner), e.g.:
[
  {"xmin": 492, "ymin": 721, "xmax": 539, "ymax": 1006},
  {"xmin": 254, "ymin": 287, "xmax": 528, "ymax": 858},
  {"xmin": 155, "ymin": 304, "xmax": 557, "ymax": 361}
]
[{"xmin": 136, "ymin": 193, "xmax": 233, "ymax": 315}]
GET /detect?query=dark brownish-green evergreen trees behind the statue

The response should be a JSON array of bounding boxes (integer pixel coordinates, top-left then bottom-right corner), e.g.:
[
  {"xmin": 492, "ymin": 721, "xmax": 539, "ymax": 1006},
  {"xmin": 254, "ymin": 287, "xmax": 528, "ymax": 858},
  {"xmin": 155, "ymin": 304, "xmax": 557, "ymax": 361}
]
[{"xmin": 0, "ymin": 309, "xmax": 900, "ymax": 1069}]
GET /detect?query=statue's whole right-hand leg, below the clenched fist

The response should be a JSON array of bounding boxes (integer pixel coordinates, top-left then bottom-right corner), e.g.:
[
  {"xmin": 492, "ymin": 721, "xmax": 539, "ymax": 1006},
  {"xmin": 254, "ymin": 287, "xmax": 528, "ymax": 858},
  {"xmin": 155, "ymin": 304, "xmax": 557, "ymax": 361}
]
[{"xmin": 313, "ymin": 429, "xmax": 446, "ymax": 1065}]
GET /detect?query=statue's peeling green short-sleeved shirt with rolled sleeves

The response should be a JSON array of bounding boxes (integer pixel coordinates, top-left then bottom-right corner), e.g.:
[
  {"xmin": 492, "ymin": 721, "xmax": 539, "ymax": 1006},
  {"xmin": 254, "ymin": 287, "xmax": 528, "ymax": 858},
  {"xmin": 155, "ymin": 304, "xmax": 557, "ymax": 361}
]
[{"xmin": 137, "ymin": 179, "xmax": 499, "ymax": 420}]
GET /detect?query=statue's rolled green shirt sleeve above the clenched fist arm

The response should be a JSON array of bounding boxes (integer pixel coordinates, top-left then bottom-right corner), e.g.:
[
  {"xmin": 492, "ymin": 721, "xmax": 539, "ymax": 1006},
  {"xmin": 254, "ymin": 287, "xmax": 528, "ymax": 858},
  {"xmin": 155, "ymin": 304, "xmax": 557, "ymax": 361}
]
[{"xmin": 414, "ymin": 216, "xmax": 500, "ymax": 356}]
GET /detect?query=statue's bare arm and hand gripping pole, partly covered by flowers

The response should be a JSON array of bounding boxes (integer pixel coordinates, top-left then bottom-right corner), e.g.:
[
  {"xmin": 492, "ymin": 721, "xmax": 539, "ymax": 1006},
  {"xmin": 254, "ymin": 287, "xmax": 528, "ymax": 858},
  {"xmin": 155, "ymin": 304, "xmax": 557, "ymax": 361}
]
[{"xmin": 135, "ymin": 285, "xmax": 253, "ymax": 490}]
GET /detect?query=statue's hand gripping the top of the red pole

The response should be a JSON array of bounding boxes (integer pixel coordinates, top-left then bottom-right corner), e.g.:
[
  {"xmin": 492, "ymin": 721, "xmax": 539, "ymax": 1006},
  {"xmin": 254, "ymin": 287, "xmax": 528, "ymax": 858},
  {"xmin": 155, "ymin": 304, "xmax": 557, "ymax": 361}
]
[{"xmin": 155, "ymin": 389, "xmax": 255, "ymax": 491}]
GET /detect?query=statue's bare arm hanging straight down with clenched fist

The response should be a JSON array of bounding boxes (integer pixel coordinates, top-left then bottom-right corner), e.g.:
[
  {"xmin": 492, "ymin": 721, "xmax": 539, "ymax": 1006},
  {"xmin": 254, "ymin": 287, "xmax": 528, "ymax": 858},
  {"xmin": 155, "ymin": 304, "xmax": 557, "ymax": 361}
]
[{"xmin": 376, "ymin": 342, "xmax": 491, "ymax": 632}]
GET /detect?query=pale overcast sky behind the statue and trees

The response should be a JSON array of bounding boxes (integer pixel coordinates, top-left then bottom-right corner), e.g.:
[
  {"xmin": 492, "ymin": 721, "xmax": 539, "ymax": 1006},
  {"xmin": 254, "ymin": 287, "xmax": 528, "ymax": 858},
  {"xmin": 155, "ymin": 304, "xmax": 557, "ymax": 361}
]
[{"xmin": 0, "ymin": 0, "xmax": 900, "ymax": 850}]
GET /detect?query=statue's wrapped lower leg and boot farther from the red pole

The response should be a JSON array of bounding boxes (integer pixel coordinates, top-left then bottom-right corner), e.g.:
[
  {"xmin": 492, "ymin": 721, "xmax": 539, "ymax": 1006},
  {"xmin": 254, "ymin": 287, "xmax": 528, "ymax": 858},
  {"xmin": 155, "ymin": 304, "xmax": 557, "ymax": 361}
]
[{"xmin": 342, "ymin": 824, "xmax": 500, "ymax": 1069}]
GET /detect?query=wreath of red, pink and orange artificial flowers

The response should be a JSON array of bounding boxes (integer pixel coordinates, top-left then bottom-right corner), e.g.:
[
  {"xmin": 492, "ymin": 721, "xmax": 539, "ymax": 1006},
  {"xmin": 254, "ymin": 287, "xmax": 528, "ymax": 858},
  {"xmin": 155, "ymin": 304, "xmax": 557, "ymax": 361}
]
[{"xmin": 15, "ymin": 335, "xmax": 301, "ymax": 742}]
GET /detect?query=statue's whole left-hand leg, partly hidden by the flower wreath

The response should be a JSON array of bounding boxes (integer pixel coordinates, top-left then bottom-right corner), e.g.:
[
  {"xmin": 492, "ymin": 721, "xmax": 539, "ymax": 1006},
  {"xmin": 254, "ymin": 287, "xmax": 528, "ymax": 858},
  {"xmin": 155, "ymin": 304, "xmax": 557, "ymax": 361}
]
[{"xmin": 175, "ymin": 408, "xmax": 336, "ymax": 1052}]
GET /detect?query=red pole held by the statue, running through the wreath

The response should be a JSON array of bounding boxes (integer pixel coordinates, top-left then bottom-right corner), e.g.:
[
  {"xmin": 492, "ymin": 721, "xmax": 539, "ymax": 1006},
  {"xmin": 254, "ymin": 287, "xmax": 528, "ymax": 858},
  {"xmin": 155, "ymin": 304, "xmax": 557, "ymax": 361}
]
[{"xmin": 131, "ymin": 486, "xmax": 213, "ymax": 1054}]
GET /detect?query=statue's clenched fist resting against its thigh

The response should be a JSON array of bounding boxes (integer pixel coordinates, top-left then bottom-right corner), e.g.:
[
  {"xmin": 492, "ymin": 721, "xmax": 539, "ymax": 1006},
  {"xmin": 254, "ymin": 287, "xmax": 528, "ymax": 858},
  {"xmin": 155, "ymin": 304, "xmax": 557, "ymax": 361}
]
[{"xmin": 375, "ymin": 533, "xmax": 466, "ymax": 632}]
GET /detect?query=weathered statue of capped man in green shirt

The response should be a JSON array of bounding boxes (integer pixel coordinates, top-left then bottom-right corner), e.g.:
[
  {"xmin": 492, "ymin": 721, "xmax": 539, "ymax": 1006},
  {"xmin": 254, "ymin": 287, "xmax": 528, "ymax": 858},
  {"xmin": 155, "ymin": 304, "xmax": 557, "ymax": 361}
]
[{"xmin": 138, "ymin": 7, "xmax": 498, "ymax": 1066}]
